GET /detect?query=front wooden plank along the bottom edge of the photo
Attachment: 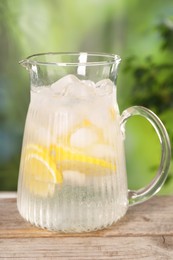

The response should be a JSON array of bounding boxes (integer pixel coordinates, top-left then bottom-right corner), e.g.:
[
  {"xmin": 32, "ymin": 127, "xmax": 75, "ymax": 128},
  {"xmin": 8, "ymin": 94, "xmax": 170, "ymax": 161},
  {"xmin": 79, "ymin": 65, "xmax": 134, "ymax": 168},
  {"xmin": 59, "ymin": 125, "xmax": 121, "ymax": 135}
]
[{"xmin": 0, "ymin": 236, "xmax": 173, "ymax": 260}]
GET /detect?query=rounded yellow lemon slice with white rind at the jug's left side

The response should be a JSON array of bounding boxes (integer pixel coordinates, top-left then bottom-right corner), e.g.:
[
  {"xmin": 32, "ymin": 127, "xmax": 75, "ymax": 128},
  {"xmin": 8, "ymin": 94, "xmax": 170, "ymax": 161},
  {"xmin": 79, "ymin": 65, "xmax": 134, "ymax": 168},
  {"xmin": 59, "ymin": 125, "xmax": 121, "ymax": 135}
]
[{"xmin": 24, "ymin": 144, "xmax": 62, "ymax": 196}]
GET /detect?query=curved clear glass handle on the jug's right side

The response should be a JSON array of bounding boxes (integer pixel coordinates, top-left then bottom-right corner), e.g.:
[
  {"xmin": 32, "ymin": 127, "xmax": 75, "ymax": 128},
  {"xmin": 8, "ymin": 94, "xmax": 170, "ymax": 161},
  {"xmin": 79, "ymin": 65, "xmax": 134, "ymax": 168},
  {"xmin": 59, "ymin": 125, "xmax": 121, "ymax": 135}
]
[{"xmin": 120, "ymin": 106, "xmax": 171, "ymax": 206}]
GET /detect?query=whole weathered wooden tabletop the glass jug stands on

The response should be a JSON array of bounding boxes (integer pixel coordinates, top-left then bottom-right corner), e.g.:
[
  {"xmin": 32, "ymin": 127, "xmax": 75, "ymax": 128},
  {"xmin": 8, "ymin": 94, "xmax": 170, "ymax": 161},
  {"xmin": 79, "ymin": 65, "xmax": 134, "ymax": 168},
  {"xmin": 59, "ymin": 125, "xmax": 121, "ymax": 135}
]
[{"xmin": 0, "ymin": 196, "xmax": 173, "ymax": 260}]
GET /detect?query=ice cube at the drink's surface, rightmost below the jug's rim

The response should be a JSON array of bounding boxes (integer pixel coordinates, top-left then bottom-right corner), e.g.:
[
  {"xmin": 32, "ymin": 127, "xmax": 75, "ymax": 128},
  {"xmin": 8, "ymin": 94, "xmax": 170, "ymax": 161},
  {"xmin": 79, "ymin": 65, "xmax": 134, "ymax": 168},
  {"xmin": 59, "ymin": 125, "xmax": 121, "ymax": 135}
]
[{"xmin": 95, "ymin": 79, "xmax": 114, "ymax": 96}]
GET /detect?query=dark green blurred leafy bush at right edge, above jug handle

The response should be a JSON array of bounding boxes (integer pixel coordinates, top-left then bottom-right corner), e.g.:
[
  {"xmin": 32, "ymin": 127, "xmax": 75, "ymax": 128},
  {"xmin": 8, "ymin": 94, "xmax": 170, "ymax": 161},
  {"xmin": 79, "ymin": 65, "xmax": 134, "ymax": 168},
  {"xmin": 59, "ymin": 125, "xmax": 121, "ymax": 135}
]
[{"xmin": 124, "ymin": 19, "xmax": 173, "ymax": 190}]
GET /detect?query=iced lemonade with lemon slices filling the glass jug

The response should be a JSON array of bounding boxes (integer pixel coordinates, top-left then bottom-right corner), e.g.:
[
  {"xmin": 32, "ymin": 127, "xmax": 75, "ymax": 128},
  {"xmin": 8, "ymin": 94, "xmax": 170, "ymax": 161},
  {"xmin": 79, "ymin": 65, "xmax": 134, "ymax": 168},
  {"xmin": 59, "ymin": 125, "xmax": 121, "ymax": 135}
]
[{"xmin": 18, "ymin": 75, "xmax": 128, "ymax": 232}]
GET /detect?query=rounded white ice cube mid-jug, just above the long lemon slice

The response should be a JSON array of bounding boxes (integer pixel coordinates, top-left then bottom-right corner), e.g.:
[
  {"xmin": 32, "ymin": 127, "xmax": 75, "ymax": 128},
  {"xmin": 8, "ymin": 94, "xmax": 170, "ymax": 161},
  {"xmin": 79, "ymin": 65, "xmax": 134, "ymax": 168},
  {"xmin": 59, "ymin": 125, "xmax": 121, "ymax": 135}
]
[{"xmin": 70, "ymin": 127, "xmax": 98, "ymax": 148}]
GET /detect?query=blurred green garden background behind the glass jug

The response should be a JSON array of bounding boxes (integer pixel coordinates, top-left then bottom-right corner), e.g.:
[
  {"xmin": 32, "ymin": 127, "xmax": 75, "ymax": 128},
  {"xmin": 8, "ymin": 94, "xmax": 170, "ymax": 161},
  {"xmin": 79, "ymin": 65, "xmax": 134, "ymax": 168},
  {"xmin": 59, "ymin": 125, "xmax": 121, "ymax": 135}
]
[{"xmin": 0, "ymin": 0, "xmax": 173, "ymax": 194}]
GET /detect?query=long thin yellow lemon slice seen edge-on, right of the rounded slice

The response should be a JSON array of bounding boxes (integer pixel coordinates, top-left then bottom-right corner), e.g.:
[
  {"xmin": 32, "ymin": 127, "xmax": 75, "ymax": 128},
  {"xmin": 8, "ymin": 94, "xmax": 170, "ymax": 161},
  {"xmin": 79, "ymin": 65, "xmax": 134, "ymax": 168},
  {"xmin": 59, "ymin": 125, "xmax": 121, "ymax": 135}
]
[{"xmin": 50, "ymin": 146, "xmax": 116, "ymax": 175}]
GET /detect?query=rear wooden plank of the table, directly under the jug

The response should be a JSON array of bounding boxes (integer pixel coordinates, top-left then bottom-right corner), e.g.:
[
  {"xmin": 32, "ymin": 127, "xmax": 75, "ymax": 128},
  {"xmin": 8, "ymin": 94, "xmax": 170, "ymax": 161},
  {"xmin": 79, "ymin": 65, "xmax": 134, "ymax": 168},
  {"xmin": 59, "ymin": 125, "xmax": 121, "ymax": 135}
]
[{"xmin": 0, "ymin": 196, "xmax": 173, "ymax": 238}]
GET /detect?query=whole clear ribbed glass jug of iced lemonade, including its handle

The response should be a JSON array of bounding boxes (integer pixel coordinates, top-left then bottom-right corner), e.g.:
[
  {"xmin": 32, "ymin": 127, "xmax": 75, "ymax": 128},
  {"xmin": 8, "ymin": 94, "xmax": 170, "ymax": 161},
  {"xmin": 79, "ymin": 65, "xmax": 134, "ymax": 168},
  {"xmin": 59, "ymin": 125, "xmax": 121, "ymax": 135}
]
[{"xmin": 17, "ymin": 52, "xmax": 171, "ymax": 232}]
